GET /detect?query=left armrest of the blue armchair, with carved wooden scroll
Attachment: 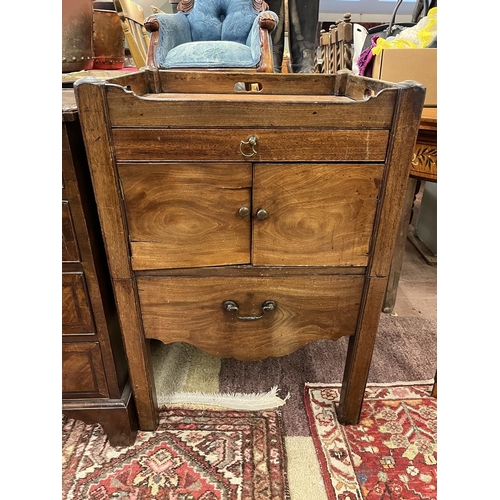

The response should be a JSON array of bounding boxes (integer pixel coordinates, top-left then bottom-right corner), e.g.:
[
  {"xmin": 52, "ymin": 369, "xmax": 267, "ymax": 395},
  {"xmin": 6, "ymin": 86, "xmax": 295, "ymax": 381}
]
[{"xmin": 144, "ymin": 12, "xmax": 192, "ymax": 67}]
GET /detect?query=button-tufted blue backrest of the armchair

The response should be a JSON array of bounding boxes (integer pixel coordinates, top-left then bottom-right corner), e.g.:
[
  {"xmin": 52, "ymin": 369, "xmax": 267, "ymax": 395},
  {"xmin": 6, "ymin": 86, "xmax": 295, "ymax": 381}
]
[{"xmin": 186, "ymin": 0, "xmax": 258, "ymax": 44}]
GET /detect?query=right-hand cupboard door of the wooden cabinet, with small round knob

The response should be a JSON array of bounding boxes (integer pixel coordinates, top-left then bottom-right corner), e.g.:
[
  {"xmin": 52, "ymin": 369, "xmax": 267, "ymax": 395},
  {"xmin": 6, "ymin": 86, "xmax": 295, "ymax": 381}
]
[{"xmin": 252, "ymin": 163, "xmax": 384, "ymax": 266}]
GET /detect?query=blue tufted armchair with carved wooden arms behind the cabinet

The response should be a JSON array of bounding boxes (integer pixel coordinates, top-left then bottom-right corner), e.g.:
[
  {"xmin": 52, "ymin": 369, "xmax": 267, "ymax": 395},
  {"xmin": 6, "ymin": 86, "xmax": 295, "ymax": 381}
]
[{"xmin": 144, "ymin": 0, "xmax": 278, "ymax": 73}]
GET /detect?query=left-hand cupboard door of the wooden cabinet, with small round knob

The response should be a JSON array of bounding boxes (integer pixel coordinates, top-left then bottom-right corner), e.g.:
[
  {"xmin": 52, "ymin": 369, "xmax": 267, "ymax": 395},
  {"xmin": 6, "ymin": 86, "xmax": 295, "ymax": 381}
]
[{"xmin": 118, "ymin": 163, "xmax": 252, "ymax": 270}]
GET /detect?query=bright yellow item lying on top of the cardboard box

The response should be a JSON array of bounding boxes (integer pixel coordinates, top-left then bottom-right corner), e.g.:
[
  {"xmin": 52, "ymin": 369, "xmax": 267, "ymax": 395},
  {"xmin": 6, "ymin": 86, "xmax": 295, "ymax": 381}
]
[{"xmin": 372, "ymin": 7, "xmax": 437, "ymax": 55}]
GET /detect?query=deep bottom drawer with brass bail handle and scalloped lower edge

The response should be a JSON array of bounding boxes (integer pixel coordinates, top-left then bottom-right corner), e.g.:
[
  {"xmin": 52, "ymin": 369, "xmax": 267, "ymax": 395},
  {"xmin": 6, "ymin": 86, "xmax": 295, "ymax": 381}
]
[{"xmin": 137, "ymin": 275, "xmax": 364, "ymax": 361}]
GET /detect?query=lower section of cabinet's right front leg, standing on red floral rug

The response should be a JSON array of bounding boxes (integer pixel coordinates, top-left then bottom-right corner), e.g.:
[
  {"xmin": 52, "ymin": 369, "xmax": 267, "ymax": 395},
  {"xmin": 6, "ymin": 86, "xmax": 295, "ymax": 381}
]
[{"xmin": 337, "ymin": 278, "xmax": 387, "ymax": 425}]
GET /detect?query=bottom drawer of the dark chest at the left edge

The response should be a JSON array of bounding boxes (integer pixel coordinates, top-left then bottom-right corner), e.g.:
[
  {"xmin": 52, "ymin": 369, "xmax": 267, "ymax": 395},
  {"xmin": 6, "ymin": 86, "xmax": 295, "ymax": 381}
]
[{"xmin": 62, "ymin": 342, "xmax": 109, "ymax": 398}]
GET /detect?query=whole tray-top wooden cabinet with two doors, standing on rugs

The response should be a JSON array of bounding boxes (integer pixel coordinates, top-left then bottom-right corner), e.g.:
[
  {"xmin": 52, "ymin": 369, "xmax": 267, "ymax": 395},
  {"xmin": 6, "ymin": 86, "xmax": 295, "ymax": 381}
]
[{"xmin": 75, "ymin": 69, "xmax": 425, "ymax": 430}]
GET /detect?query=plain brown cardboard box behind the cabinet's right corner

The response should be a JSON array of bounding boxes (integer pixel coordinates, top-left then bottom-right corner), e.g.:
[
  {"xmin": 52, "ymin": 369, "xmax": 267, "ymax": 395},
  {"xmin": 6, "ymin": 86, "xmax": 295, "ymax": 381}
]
[{"xmin": 372, "ymin": 49, "xmax": 437, "ymax": 107}]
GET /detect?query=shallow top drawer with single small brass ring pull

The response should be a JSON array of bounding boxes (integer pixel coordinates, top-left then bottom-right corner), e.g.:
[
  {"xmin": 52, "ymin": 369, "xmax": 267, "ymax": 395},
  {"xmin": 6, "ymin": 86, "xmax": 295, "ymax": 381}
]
[{"xmin": 112, "ymin": 128, "xmax": 389, "ymax": 162}]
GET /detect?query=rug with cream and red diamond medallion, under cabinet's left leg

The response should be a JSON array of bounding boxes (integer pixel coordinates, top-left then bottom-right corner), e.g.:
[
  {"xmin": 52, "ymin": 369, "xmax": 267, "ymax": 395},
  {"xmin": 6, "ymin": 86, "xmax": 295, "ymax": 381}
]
[{"xmin": 62, "ymin": 406, "xmax": 289, "ymax": 500}]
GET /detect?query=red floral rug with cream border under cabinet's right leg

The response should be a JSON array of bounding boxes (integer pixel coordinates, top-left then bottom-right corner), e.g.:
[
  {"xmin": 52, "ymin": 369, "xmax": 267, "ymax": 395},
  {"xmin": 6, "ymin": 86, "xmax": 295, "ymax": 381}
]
[{"xmin": 304, "ymin": 384, "xmax": 437, "ymax": 500}]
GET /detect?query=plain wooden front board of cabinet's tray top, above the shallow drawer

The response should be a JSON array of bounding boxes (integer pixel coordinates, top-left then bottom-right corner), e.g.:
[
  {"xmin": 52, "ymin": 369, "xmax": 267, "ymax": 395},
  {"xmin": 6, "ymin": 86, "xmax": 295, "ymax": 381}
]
[{"xmin": 107, "ymin": 83, "xmax": 397, "ymax": 129}]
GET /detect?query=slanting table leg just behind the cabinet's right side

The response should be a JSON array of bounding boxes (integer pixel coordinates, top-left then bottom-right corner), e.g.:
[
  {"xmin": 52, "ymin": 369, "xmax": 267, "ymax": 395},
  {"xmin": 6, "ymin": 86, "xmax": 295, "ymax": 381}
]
[{"xmin": 382, "ymin": 177, "xmax": 418, "ymax": 313}]
